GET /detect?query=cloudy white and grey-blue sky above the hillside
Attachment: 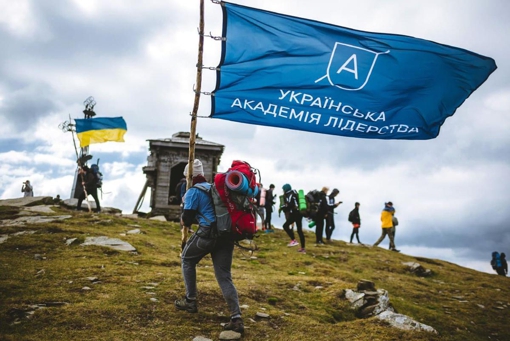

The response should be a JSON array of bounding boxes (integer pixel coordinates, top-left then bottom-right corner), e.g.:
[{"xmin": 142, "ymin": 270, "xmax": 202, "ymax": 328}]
[{"xmin": 0, "ymin": 0, "xmax": 510, "ymax": 273}]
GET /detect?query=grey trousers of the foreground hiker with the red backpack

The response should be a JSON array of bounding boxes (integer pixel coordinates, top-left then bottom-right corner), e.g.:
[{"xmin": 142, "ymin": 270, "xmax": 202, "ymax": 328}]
[{"xmin": 181, "ymin": 233, "xmax": 241, "ymax": 318}]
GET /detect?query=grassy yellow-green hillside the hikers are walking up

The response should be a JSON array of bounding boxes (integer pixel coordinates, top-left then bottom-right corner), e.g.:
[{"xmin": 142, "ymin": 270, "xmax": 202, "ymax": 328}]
[{"xmin": 0, "ymin": 207, "xmax": 510, "ymax": 341}]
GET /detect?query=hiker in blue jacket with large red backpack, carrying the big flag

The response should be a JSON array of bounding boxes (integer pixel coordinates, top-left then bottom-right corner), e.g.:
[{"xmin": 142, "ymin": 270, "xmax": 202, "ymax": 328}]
[{"xmin": 175, "ymin": 159, "xmax": 259, "ymax": 334}]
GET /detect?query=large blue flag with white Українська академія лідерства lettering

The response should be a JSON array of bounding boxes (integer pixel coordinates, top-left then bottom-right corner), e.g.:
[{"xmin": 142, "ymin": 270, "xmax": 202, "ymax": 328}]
[{"xmin": 210, "ymin": 2, "xmax": 496, "ymax": 140}]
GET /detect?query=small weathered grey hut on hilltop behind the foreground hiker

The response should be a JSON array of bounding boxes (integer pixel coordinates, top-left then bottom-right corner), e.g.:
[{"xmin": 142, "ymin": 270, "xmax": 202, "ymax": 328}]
[{"xmin": 133, "ymin": 132, "xmax": 225, "ymax": 216}]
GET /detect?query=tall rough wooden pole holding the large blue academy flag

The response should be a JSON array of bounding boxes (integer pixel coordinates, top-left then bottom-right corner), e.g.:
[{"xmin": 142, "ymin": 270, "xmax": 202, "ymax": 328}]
[{"xmin": 181, "ymin": 0, "xmax": 204, "ymax": 248}]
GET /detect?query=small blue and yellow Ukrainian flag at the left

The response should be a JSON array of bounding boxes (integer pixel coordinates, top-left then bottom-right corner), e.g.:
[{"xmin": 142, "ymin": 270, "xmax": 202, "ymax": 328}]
[{"xmin": 75, "ymin": 117, "xmax": 127, "ymax": 148}]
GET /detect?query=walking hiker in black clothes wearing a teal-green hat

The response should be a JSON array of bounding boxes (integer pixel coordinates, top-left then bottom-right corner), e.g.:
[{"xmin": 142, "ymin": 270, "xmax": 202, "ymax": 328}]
[{"xmin": 282, "ymin": 184, "xmax": 306, "ymax": 254}]
